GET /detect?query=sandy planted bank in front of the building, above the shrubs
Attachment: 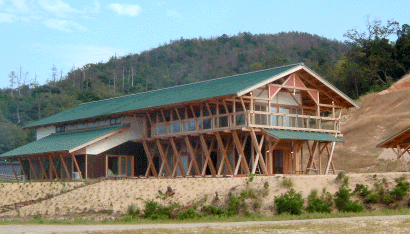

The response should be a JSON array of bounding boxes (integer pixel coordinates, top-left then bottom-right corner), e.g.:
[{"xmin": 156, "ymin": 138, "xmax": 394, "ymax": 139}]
[{"xmin": 0, "ymin": 172, "xmax": 410, "ymax": 218}]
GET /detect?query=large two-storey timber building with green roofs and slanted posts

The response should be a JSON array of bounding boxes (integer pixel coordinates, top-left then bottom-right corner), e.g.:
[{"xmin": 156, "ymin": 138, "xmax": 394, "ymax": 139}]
[{"xmin": 0, "ymin": 64, "xmax": 359, "ymax": 180}]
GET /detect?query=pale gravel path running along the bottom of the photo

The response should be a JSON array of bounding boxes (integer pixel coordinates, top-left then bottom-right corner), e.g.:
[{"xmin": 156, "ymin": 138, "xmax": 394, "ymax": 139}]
[{"xmin": 0, "ymin": 215, "xmax": 410, "ymax": 234}]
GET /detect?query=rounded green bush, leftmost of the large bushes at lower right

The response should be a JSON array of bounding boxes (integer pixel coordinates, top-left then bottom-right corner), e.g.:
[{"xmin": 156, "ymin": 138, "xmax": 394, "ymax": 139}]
[{"xmin": 274, "ymin": 189, "xmax": 305, "ymax": 215}]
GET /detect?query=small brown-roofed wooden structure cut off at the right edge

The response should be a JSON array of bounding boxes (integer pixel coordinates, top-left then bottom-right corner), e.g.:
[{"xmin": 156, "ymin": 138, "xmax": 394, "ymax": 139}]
[{"xmin": 377, "ymin": 127, "xmax": 410, "ymax": 171}]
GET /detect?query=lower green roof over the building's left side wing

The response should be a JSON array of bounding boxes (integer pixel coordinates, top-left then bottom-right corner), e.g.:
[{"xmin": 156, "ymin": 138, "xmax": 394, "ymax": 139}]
[{"xmin": 0, "ymin": 124, "xmax": 129, "ymax": 157}]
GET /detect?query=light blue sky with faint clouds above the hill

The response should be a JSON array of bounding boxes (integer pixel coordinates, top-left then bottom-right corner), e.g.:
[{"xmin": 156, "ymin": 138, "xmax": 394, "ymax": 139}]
[{"xmin": 0, "ymin": 0, "xmax": 410, "ymax": 88}]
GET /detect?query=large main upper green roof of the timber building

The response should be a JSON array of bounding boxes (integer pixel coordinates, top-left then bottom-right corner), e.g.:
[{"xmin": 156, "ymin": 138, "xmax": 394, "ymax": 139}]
[{"xmin": 26, "ymin": 63, "xmax": 302, "ymax": 128}]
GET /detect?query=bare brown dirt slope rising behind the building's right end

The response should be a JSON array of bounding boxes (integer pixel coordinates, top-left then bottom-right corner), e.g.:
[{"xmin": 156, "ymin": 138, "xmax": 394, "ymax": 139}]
[{"xmin": 335, "ymin": 74, "xmax": 410, "ymax": 172}]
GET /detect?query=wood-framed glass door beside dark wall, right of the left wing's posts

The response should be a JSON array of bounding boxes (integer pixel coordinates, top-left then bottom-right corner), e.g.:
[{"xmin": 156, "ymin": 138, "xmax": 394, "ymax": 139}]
[{"xmin": 105, "ymin": 155, "xmax": 134, "ymax": 177}]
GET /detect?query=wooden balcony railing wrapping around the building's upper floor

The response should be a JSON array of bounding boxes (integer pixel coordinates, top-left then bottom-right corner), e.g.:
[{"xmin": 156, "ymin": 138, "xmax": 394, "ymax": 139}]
[{"xmin": 151, "ymin": 111, "xmax": 340, "ymax": 136}]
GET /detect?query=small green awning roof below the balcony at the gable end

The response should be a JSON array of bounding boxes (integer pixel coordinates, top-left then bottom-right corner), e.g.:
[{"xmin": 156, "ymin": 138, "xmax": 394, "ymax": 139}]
[{"xmin": 263, "ymin": 129, "xmax": 344, "ymax": 142}]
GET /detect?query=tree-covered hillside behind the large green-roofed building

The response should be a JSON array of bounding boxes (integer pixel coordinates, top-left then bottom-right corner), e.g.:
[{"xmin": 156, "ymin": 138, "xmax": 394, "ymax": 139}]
[{"xmin": 0, "ymin": 22, "xmax": 410, "ymax": 159}]
